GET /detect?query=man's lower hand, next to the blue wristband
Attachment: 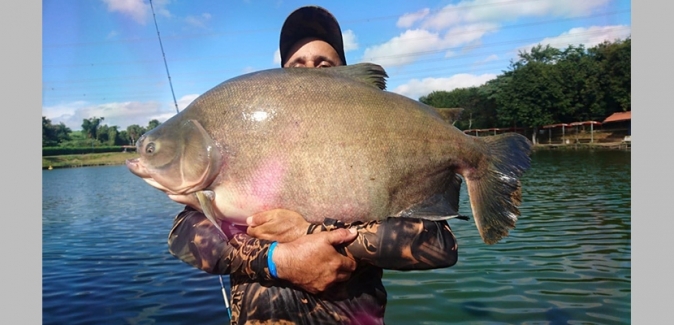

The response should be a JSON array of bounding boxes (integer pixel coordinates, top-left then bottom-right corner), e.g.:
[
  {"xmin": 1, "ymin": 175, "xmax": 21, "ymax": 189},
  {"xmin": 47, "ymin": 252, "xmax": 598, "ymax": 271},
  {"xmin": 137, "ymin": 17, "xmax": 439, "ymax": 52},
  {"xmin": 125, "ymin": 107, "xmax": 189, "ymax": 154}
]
[{"xmin": 272, "ymin": 228, "xmax": 358, "ymax": 294}]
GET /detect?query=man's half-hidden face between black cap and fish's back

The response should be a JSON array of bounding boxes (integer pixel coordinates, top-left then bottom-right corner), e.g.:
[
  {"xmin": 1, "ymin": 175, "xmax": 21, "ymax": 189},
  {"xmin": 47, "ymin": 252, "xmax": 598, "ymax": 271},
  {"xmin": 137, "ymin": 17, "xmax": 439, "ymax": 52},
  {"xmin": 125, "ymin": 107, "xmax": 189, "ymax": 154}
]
[{"xmin": 283, "ymin": 37, "xmax": 343, "ymax": 68}]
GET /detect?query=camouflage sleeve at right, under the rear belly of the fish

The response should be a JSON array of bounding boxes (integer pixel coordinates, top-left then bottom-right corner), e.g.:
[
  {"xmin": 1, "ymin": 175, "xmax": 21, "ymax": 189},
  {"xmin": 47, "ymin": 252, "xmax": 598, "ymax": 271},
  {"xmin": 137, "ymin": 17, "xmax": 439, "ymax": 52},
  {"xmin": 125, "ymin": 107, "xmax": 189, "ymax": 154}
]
[{"xmin": 310, "ymin": 218, "xmax": 458, "ymax": 270}]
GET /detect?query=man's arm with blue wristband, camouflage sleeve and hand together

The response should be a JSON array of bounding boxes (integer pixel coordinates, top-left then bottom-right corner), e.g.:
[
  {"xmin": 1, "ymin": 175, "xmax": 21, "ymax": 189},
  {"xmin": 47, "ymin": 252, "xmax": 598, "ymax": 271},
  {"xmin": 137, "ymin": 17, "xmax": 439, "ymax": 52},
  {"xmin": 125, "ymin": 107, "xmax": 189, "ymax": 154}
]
[{"xmin": 168, "ymin": 207, "xmax": 357, "ymax": 293}]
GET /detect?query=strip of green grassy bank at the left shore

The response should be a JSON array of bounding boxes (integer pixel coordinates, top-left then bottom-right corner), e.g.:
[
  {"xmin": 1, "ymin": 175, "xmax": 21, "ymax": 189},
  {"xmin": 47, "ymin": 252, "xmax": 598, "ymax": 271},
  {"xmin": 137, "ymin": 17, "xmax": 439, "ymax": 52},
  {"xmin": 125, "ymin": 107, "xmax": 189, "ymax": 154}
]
[{"xmin": 42, "ymin": 151, "xmax": 138, "ymax": 169}]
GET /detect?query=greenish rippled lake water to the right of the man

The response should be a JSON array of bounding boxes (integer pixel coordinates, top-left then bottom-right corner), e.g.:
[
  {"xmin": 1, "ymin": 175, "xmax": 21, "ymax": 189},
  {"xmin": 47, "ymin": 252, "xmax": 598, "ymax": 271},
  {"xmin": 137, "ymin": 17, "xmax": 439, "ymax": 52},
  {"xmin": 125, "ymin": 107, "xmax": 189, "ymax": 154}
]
[{"xmin": 385, "ymin": 151, "xmax": 631, "ymax": 324}]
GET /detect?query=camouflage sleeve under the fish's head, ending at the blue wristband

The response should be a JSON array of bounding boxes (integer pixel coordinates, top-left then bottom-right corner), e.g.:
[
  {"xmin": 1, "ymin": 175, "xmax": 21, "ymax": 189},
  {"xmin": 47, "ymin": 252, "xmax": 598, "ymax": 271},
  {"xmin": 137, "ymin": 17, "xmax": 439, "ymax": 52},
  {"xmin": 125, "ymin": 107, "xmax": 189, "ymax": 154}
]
[{"xmin": 168, "ymin": 207, "xmax": 271, "ymax": 281}]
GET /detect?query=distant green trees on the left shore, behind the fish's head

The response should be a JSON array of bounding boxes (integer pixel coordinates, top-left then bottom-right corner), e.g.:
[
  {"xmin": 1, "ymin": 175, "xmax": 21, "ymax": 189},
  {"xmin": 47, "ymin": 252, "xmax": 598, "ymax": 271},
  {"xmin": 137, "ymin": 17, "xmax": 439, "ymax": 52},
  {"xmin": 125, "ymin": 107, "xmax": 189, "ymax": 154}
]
[{"xmin": 42, "ymin": 116, "xmax": 161, "ymax": 148}]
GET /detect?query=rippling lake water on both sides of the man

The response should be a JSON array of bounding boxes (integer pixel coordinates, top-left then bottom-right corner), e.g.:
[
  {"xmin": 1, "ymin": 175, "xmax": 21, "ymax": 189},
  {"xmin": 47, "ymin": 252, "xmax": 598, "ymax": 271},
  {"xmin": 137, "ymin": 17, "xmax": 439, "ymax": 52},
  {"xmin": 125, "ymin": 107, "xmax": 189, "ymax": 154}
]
[{"xmin": 42, "ymin": 150, "xmax": 631, "ymax": 325}]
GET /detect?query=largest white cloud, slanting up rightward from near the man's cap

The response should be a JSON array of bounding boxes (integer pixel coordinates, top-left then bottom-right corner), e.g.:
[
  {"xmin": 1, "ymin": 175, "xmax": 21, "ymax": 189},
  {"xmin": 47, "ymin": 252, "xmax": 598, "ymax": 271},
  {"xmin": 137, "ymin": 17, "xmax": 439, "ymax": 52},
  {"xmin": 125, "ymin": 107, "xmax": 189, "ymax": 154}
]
[{"xmin": 362, "ymin": 0, "xmax": 610, "ymax": 66}]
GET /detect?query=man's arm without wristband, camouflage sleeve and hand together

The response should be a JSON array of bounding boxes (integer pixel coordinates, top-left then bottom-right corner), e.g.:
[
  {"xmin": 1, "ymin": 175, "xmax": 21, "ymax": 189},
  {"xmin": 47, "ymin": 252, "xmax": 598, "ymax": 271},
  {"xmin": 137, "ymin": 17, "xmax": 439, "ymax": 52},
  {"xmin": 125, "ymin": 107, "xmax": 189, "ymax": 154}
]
[{"xmin": 247, "ymin": 210, "xmax": 458, "ymax": 270}]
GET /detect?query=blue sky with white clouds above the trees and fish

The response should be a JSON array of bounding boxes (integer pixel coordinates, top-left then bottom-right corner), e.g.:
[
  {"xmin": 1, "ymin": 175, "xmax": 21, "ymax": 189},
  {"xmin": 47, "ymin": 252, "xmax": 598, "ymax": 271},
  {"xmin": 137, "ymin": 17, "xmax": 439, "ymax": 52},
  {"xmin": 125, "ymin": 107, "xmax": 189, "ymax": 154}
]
[{"xmin": 42, "ymin": 0, "xmax": 631, "ymax": 130}]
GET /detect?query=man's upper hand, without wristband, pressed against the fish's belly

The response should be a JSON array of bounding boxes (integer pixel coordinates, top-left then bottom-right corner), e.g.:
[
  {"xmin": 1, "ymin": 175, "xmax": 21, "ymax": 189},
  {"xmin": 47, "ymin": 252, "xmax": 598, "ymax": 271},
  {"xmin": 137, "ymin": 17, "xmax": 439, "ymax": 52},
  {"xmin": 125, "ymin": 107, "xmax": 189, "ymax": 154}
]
[{"xmin": 246, "ymin": 209, "xmax": 309, "ymax": 243}]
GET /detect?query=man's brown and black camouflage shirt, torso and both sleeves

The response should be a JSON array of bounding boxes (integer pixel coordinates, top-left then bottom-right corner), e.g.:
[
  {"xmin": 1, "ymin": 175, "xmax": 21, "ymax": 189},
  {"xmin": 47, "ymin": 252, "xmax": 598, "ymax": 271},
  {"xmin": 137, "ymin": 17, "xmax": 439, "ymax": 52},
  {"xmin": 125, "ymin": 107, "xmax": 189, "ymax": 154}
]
[{"xmin": 168, "ymin": 207, "xmax": 457, "ymax": 324}]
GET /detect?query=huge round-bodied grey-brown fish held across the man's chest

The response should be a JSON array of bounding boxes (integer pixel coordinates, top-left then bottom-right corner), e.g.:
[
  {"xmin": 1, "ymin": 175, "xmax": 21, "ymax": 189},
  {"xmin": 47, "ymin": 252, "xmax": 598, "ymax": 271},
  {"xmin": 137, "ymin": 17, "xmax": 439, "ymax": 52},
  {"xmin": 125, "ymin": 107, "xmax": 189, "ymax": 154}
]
[{"xmin": 127, "ymin": 63, "xmax": 531, "ymax": 244}]
